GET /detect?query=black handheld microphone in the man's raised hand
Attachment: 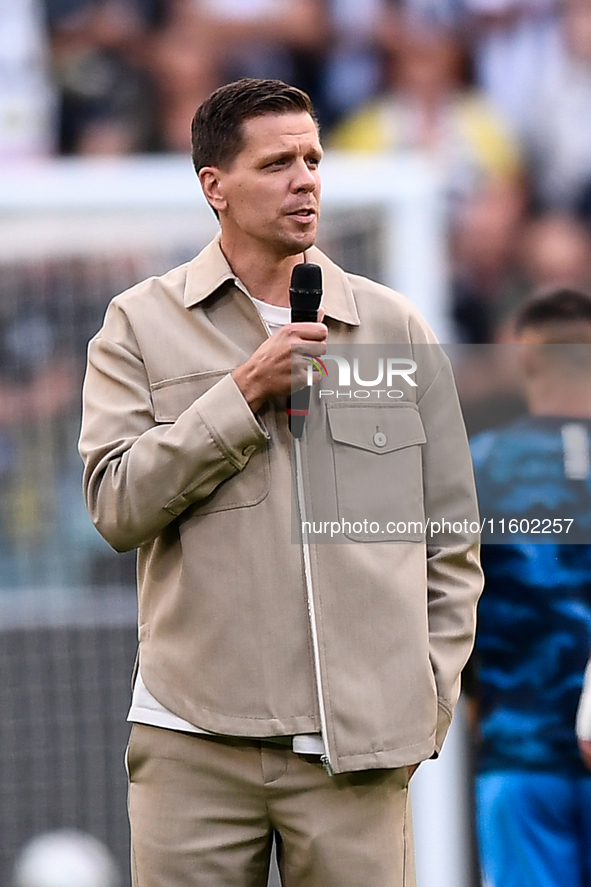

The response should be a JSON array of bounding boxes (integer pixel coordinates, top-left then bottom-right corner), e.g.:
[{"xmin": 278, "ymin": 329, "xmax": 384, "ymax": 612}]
[{"xmin": 287, "ymin": 262, "xmax": 322, "ymax": 437}]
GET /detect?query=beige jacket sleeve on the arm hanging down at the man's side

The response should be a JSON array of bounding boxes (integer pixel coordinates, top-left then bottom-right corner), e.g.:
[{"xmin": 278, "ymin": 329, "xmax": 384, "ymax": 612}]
[{"xmin": 419, "ymin": 345, "xmax": 483, "ymax": 754}]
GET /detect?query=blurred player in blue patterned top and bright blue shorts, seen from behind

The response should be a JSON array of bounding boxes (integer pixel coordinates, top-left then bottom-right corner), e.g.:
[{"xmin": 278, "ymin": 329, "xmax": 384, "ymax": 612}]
[{"xmin": 472, "ymin": 289, "xmax": 591, "ymax": 887}]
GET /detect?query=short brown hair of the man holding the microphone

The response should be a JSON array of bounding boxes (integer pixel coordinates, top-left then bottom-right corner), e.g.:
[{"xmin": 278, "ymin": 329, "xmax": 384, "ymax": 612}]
[{"xmin": 191, "ymin": 77, "xmax": 318, "ymax": 174}]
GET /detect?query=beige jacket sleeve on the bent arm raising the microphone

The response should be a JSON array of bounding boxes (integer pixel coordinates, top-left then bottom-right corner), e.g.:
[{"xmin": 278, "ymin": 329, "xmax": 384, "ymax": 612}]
[{"xmin": 79, "ymin": 300, "xmax": 268, "ymax": 551}]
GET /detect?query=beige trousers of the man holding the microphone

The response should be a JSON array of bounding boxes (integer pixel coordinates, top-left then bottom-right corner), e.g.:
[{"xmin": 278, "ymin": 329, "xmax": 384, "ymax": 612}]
[{"xmin": 127, "ymin": 724, "xmax": 415, "ymax": 887}]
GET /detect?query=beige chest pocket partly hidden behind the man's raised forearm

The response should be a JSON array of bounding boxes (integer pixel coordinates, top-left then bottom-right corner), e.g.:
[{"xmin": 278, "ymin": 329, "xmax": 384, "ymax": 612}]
[{"xmin": 151, "ymin": 367, "xmax": 271, "ymax": 519}]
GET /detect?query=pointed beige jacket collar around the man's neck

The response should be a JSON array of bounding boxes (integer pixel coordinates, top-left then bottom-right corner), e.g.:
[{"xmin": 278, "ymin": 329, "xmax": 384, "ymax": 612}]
[{"xmin": 184, "ymin": 234, "xmax": 359, "ymax": 326}]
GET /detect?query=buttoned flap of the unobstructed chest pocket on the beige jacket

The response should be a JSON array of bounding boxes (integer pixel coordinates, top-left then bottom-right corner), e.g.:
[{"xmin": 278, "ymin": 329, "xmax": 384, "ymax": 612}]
[{"xmin": 328, "ymin": 403, "xmax": 427, "ymax": 455}]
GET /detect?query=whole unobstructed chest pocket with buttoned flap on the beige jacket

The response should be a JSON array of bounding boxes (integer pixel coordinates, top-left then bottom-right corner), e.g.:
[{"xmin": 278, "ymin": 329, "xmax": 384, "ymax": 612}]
[{"xmin": 328, "ymin": 403, "xmax": 427, "ymax": 542}]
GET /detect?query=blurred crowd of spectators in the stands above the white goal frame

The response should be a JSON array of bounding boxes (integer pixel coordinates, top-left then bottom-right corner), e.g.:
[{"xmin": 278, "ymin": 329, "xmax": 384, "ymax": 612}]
[{"xmin": 0, "ymin": 0, "xmax": 591, "ymax": 343}]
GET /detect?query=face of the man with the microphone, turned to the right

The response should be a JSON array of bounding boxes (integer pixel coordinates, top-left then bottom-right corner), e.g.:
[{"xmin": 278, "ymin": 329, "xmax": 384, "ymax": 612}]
[{"xmin": 201, "ymin": 112, "xmax": 322, "ymax": 259}]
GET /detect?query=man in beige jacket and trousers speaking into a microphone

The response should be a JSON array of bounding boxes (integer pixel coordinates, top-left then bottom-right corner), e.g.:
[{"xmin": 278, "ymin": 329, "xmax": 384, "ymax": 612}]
[{"xmin": 80, "ymin": 80, "xmax": 481, "ymax": 887}]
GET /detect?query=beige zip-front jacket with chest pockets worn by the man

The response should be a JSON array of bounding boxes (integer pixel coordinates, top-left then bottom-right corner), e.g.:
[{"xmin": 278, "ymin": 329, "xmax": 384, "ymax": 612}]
[{"xmin": 80, "ymin": 240, "xmax": 481, "ymax": 772}]
